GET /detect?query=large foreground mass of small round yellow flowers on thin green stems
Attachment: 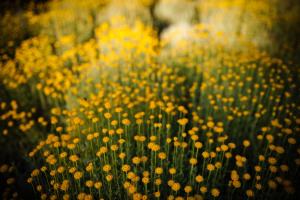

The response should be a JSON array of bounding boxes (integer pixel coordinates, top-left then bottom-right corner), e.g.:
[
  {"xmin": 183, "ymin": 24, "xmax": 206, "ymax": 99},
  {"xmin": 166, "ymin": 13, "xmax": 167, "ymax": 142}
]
[{"xmin": 0, "ymin": 1, "xmax": 300, "ymax": 200}]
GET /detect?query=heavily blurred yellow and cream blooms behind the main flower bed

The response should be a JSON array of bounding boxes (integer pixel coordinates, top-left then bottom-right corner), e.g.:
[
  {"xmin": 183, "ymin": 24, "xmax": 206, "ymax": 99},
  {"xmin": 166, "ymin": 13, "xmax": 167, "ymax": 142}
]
[{"xmin": 0, "ymin": 0, "xmax": 300, "ymax": 61}]
